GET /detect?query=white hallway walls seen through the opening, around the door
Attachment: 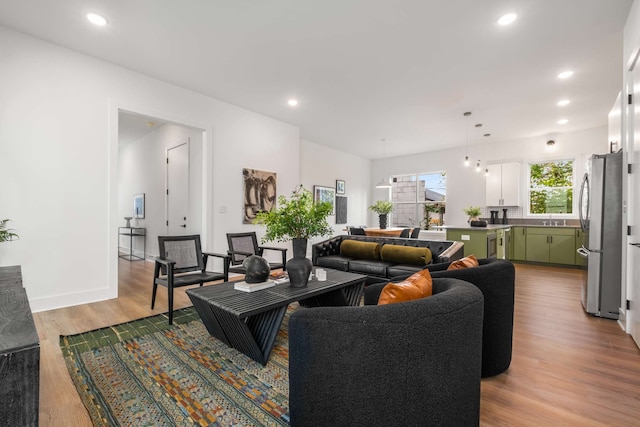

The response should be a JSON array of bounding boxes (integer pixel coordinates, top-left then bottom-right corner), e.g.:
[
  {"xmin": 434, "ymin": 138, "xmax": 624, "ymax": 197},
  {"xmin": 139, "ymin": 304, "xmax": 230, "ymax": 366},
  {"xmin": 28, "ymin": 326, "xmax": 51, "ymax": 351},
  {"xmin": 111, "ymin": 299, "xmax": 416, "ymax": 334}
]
[{"xmin": 118, "ymin": 124, "xmax": 203, "ymax": 258}]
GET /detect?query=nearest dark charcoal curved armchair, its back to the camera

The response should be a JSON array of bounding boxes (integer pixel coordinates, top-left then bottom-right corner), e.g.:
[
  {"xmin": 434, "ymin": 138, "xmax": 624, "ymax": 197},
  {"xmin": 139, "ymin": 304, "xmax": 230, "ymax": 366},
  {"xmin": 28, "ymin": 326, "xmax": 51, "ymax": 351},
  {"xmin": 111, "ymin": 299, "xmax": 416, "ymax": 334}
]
[{"xmin": 289, "ymin": 279, "xmax": 483, "ymax": 427}]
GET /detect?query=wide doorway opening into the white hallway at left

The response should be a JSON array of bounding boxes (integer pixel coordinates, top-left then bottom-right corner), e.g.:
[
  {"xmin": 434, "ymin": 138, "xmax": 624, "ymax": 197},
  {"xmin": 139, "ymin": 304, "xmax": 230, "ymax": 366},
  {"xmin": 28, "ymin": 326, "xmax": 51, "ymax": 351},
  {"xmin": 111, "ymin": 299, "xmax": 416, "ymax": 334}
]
[{"xmin": 117, "ymin": 110, "xmax": 206, "ymax": 260}]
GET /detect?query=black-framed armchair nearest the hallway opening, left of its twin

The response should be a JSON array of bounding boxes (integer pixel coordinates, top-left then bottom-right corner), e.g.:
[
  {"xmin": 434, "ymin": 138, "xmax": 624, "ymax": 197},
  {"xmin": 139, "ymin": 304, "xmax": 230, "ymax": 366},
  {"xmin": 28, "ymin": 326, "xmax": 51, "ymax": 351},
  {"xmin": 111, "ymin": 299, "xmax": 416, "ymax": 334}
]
[{"xmin": 151, "ymin": 234, "xmax": 231, "ymax": 325}]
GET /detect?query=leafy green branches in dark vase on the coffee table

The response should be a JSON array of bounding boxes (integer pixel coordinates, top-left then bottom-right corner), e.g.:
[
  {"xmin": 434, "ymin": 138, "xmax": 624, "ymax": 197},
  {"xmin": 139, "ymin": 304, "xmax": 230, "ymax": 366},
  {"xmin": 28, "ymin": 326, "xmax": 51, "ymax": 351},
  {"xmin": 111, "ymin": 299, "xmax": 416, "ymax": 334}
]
[{"xmin": 254, "ymin": 185, "xmax": 333, "ymax": 287}]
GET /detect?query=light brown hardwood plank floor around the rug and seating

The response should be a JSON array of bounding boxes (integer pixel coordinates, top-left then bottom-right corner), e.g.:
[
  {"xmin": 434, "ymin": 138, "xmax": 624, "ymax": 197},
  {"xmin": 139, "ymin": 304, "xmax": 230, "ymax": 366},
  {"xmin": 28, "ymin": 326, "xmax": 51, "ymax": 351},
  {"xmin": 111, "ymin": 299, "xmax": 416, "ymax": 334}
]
[{"xmin": 34, "ymin": 260, "xmax": 640, "ymax": 426}]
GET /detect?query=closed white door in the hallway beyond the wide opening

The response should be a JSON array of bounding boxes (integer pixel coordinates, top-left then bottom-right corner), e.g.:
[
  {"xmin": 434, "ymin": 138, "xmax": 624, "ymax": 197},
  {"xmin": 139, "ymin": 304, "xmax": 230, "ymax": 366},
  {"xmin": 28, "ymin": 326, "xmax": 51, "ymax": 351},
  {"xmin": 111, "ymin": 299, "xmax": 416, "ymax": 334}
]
[{"xmin": 166, "ymin": 140, "xmax": 189, "ymax": 236}]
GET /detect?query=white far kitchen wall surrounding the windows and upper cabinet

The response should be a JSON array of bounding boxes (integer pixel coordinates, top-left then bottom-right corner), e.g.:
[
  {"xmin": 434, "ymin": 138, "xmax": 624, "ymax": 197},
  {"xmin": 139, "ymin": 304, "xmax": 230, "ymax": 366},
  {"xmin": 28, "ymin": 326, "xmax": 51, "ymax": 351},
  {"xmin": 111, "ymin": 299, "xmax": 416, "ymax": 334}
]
[{"xmin": 369, "ymin": 127, "xmax": 614, "ymax": 225}]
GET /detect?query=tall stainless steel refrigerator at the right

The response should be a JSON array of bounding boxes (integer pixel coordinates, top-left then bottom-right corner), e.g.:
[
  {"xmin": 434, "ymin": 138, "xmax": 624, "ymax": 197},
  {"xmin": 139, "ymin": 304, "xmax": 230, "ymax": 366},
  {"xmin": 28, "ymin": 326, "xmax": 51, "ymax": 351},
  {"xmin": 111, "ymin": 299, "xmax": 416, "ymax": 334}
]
[{"xmin": 578, "ymin": 152, "xmax": 622, "ymax": 319}]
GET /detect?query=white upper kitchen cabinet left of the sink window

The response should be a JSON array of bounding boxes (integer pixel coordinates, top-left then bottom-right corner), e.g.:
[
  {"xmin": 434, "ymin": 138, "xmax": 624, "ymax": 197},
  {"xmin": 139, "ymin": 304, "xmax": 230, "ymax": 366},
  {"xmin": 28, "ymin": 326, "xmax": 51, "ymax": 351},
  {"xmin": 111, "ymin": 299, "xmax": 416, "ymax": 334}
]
[{"xmin": 485, "ymin": 163, "xmax": 521, "ymax": 206}]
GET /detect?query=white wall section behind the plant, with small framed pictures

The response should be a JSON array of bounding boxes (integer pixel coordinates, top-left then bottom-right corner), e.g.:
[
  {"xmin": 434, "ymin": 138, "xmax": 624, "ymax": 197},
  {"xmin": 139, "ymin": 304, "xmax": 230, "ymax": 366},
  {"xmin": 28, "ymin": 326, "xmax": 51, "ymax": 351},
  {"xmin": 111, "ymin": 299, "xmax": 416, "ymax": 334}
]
[{"xmin": 302, "ymin": 140, "xmax": 373, "ymax": 252}]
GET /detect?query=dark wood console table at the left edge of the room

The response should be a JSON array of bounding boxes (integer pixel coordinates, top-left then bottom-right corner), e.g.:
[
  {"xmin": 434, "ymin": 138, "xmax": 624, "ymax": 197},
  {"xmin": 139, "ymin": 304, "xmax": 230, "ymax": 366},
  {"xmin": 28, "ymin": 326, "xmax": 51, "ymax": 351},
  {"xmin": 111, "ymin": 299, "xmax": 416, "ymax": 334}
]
[{"xmin": 0, "ymin": 266, "xmax": 40, "ymax": 426}]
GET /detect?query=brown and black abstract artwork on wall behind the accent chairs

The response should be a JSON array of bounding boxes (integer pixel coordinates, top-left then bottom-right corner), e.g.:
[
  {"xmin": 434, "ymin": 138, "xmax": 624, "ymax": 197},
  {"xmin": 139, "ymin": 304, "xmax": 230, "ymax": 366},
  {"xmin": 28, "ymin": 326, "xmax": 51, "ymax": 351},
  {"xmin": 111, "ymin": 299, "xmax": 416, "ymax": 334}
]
[{"xmin": 242, "ymin": 169, "xmax": 276, "ymax": 224}]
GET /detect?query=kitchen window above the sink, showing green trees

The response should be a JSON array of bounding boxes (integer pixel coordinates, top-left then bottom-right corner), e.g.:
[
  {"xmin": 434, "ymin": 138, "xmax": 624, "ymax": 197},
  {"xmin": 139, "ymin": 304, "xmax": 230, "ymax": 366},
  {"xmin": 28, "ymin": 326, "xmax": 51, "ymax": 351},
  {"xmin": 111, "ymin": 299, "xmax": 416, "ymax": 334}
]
[{"xmin": 529, "ymin": 160, "xmax": 574, "ymax": 215}]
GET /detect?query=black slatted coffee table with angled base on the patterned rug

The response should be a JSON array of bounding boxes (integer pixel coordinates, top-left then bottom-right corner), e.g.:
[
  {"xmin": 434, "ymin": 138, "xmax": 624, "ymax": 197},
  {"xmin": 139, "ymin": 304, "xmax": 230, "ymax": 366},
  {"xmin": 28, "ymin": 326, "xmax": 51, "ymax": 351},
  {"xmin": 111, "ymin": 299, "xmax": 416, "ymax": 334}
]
[{"xmin": 187, "ymin": 269, "xmax": 366, "ymax": 365}]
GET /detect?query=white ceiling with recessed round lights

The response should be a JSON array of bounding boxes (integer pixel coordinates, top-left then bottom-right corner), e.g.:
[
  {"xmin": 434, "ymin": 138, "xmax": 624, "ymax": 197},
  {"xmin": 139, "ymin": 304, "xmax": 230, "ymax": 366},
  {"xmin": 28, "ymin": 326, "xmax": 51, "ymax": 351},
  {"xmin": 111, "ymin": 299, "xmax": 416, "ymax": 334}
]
[{"xmin": 0, "ymin": 0, "xmax": 632, "ymax": 158}]
